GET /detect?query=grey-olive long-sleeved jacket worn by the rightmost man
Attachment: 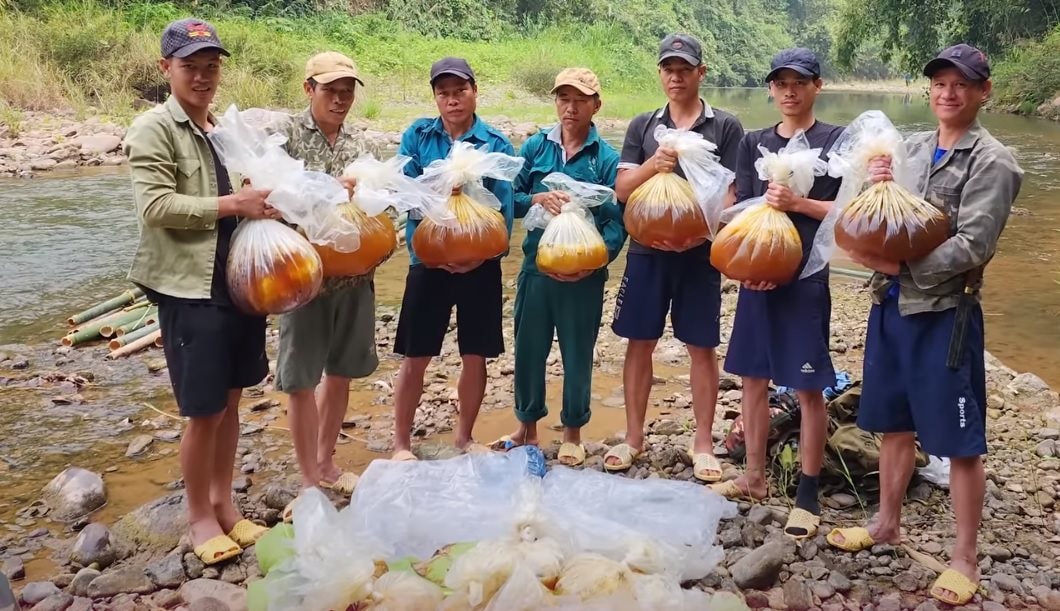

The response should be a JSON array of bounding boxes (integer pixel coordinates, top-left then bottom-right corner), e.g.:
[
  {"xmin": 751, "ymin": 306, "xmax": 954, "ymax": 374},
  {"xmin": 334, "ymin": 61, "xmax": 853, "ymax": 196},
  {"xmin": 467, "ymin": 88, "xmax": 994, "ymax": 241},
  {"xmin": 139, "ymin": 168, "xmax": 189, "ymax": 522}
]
[{"xmin": 869, "ymin": 121, "xmax": 1023, "ymax": 316}]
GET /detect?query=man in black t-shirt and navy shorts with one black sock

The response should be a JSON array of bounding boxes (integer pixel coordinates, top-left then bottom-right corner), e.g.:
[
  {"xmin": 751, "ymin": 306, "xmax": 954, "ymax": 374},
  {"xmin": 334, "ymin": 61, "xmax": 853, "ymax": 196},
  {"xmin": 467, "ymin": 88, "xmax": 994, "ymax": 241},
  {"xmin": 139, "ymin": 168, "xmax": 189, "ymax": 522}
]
[{"xmin": 713, "ymin": 49, "xmax": 843, "ymax": 538}]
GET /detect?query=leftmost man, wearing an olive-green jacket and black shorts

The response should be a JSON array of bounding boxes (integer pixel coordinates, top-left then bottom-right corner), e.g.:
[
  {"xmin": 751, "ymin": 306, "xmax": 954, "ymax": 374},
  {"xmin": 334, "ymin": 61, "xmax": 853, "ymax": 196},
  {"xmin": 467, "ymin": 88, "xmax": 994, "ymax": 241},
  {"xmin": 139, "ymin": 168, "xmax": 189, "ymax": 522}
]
[{"xmin": 125, "ymin": 19, "xmax": 280, "ymax": 564}]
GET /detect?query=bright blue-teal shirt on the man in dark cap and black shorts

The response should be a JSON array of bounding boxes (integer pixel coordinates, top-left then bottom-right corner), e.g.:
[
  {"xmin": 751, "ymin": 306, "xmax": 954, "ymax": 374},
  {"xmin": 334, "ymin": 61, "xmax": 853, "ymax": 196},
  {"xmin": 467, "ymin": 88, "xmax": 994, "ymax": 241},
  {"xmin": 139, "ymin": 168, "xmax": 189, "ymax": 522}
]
[{"xmin": 398, "ymin": 116, "xmax": 515, "ymax": 265}]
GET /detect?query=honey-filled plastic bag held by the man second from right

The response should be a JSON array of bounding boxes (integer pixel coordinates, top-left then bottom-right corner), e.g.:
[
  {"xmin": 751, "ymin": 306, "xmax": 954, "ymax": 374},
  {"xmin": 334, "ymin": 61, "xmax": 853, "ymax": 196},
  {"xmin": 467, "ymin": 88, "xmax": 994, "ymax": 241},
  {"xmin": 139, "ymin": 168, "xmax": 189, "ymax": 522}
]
[{"xmin": 710, "ymin": 130, "xmax": 828, "ymax": 284}]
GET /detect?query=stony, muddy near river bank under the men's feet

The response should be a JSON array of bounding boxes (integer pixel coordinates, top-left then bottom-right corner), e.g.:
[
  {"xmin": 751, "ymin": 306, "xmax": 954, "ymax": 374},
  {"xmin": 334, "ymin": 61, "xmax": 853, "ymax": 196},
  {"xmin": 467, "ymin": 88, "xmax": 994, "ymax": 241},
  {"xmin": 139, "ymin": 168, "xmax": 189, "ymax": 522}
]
[{"xmin": 0, "ymin": 276, "xmax": 1060, "ymax": 611}]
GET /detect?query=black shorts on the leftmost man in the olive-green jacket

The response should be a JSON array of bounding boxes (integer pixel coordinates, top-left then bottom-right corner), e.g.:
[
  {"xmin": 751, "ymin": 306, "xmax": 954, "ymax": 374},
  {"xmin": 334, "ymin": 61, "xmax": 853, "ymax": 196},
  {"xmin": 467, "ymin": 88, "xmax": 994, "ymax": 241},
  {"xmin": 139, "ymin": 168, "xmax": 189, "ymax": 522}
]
[{"xmin": 158, "ymin": 300, "xmax": 268, "ymax": 418}]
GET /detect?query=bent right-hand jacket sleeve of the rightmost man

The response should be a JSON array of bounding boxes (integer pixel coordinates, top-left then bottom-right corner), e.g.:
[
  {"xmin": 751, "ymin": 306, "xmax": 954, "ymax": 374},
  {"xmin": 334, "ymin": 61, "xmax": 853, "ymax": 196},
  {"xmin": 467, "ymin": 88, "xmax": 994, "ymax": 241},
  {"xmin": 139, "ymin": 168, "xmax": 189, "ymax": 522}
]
[{"xmin": 906, "ymin": 151, "xmax": 1023, "ymax": 290}]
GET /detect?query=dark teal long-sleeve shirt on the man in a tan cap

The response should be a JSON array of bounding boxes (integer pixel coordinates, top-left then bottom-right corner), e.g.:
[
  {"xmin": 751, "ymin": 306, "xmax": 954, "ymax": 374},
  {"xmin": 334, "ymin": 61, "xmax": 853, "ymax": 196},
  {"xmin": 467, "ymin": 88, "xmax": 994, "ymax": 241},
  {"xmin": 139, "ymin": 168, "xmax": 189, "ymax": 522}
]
[{"xmin": 515, "ymin": 125, "xmax": 626, "ymax": 274}]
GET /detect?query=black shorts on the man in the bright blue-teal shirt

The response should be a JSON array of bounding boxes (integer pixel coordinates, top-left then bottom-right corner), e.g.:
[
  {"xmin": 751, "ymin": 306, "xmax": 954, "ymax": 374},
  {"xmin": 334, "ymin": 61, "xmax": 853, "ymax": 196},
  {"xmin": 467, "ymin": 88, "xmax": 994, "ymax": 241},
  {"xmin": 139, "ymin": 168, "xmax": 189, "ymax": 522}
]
[{"xmin": 394, "ymin": 259, "xmax": 505, "ymax": 359}]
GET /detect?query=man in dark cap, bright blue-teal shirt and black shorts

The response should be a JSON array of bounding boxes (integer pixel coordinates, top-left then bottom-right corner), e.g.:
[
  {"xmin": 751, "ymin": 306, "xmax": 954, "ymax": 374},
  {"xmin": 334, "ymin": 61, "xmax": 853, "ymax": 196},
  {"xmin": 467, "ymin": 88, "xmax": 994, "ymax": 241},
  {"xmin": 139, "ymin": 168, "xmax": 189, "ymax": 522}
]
[{"xmin": 393, "ymin": 57, "xmax": 515, "ymax": 460}]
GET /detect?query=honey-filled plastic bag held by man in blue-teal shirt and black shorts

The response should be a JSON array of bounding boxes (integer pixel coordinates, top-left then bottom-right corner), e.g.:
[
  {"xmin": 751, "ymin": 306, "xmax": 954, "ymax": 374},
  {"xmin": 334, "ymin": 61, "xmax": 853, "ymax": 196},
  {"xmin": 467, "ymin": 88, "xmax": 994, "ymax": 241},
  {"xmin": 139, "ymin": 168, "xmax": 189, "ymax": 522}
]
[{"xmin": 412, "ymin": 141, "xmax": 524, "ymax": 267}]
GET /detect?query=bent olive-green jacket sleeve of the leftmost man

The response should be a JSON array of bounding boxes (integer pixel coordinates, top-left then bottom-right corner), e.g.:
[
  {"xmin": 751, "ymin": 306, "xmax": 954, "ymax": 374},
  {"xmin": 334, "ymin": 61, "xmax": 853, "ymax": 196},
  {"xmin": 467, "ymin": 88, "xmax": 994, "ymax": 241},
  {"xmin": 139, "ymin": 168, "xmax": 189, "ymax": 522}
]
[{"xmin": 125, "ymin": 121, "xmax": 219, "ymax": 230}]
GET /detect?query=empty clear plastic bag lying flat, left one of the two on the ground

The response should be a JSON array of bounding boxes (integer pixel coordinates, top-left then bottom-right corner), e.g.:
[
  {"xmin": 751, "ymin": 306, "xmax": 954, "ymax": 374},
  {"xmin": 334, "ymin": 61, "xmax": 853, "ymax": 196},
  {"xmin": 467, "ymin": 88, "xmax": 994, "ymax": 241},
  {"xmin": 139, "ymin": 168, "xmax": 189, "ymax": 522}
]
[{"xmin": 345, "ymin": 448, "xmax": 533, "ymax": 560}]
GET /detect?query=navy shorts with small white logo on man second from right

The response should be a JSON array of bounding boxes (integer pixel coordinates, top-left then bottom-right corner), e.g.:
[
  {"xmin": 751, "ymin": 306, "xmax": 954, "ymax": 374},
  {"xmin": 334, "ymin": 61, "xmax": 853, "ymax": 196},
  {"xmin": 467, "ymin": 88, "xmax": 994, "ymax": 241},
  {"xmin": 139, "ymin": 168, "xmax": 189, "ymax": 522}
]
[{"xmin": 725, "ymin": 280, "xmax": 835, "ymax": 390}]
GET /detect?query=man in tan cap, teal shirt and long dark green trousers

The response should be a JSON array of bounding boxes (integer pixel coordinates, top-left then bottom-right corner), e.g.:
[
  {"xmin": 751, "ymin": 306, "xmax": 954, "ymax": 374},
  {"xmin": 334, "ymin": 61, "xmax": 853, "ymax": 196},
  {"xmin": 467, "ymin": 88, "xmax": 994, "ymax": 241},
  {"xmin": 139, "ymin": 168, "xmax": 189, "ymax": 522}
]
[{"xmin": 495, "ymin": 68, "xmax": 625, "ymax": 466}]
